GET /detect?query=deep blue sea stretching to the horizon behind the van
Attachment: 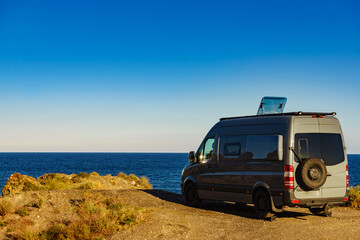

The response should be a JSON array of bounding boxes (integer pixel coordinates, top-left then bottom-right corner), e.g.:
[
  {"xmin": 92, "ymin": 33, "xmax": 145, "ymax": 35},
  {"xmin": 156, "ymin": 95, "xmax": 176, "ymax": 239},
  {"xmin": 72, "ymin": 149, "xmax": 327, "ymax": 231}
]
[{"xmin": 0, "ymin": 153, "xmax": 360, "ymax": 196}]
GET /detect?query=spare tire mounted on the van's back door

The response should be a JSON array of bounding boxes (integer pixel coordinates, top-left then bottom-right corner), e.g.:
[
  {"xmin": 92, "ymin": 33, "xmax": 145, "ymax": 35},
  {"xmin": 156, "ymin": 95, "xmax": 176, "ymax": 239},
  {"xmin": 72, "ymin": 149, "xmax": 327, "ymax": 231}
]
[{"xmin": 296, "ymin": 158, "xmax": 327, "ymax": 191}]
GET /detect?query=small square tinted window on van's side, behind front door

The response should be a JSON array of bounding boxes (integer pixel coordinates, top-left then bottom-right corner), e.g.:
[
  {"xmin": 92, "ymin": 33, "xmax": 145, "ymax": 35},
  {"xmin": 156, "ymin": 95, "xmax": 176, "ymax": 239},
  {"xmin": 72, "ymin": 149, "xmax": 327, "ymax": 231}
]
[{"xmin": 219, "ymin": 135, "xmax": 246, "ymax": 164}]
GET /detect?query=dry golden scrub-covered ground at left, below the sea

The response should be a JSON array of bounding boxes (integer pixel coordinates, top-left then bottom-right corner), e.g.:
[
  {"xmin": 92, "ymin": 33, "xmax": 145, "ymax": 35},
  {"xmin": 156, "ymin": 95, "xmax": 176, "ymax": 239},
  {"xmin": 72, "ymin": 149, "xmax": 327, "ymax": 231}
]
[{"xmin": 0, "ymin": 173, "xmax": 152, "ymax": 240}]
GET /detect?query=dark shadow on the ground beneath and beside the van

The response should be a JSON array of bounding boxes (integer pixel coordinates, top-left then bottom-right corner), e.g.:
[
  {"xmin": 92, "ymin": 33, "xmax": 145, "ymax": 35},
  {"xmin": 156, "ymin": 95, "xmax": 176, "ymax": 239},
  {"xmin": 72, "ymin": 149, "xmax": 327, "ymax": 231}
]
[{"xmin": 141, "ymin": 189, "xmax": 312, "ymax": 220}]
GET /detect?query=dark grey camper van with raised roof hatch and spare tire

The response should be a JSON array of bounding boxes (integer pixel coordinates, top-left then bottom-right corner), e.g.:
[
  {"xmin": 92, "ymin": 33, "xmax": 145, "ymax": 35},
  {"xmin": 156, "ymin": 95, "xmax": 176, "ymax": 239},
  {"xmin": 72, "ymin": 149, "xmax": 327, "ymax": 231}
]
[{"xmin": 181, "ymin": 97, "xmax": 349, "ymax": 218}]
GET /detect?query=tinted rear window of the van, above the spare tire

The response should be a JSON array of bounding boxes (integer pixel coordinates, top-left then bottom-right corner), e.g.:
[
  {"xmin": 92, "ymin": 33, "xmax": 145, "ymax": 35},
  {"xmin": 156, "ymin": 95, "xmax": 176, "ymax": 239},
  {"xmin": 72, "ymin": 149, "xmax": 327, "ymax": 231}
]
[{"xmin": 295, "ymin": 133, "xmax": 344, "ymax": 166}]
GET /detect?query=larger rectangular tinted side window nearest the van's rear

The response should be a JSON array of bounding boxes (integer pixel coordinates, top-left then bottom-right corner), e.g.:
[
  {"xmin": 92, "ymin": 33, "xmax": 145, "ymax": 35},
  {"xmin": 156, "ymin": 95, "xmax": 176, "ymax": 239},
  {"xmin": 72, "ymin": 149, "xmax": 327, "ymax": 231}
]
[{"xmin": 246, "ymin": 135, "xmax": 279, "ymax": 160}]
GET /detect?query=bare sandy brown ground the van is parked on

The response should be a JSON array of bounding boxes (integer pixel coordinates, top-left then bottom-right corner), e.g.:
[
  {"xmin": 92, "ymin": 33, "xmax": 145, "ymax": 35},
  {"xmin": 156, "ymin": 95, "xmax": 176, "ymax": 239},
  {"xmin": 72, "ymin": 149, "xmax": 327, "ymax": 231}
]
[{"xmin": 0, "ymin": 190, "xmax": 360, "ymax": 240}]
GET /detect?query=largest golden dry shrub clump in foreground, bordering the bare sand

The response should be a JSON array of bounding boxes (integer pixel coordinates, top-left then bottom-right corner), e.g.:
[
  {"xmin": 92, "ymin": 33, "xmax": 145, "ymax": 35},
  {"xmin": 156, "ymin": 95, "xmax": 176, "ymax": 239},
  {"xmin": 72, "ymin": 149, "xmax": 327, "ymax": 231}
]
[{"xmin": 38, "ymin": 191, "xmax": 142, "ymax": 240}]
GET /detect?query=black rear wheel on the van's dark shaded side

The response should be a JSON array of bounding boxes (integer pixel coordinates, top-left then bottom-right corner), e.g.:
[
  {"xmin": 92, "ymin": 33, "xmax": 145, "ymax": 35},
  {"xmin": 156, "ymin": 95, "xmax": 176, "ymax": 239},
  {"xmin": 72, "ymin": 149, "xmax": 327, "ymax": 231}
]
[{"xmin": 253, "ymin": 189, "xmax": 274, "ymax": 219}]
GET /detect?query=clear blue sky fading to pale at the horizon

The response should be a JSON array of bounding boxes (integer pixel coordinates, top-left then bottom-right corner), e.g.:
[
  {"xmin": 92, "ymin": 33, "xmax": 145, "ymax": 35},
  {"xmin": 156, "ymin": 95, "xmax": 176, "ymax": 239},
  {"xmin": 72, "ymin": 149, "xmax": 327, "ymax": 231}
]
[{"xmin": 0, "ymin": 0, "xmax": 360, "ymax": 153}]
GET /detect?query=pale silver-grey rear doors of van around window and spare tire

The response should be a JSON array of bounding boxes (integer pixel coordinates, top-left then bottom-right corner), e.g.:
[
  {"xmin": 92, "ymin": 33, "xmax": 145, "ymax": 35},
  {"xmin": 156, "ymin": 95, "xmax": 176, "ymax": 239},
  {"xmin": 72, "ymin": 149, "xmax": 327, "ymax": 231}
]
[{"xmin": 294, "ymin": 118, "xmax": 347, "ymax": 199}]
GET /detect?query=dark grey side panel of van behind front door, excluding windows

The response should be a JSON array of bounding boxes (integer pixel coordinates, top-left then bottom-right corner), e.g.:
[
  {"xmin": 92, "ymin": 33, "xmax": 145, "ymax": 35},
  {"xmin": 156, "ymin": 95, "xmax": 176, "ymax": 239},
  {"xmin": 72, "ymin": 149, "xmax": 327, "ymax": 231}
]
[{"xmin": 214, "ymin": 121, "xmax": 289, "ymax": 205}]
